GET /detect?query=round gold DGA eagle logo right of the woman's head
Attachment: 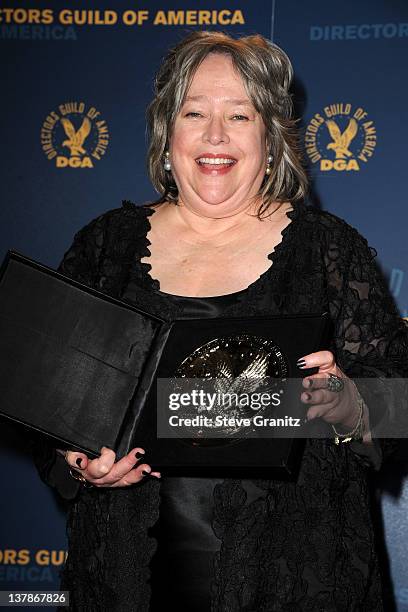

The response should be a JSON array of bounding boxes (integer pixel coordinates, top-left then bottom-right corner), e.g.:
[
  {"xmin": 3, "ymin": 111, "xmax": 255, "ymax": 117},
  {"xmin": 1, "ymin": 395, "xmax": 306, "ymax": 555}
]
[{"xmin": 305, "ymin": 103, "xmax": 377, "ymax": 172}]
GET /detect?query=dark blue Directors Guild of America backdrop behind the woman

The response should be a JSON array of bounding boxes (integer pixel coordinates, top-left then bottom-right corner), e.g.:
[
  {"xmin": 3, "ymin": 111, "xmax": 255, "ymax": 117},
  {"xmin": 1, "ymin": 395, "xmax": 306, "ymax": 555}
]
[{"xmin": 0, "ymin": 0, "xmax": 408, "ymax": 612}]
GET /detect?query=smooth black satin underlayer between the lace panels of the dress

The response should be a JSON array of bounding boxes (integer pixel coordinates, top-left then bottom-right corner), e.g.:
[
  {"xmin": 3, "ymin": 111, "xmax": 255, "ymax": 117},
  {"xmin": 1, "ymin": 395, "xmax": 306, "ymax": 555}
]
[{"xmin": 150, "ymin": 290, "xmax": 246, "ymax": 612}]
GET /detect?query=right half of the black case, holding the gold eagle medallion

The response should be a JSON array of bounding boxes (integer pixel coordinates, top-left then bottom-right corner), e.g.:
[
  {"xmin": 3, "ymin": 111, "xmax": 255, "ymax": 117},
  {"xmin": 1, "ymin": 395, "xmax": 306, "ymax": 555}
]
[{"xmin": 127, "ymin": 315, "xmax": 330, "ymax": 479}]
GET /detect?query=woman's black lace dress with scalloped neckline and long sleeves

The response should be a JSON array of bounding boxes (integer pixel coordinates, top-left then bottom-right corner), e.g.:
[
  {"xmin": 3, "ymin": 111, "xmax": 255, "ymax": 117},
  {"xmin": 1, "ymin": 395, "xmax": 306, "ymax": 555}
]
[{"xmin": 34, "ymin": 203, "xmax": 408, "ymax": 612}]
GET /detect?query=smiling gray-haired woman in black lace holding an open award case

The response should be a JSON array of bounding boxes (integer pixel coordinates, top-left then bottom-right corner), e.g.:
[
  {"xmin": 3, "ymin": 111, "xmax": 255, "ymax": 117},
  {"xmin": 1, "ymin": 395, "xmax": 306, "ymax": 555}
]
[{"xmin": 32, "ymin": 32, "xmax": 407, "ymax": 612}]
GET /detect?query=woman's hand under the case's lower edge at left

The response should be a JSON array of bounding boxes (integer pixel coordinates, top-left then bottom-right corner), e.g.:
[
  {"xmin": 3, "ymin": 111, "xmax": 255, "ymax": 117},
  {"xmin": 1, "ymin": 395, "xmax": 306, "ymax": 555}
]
[{"xmin": 59, "ymin": 446, "xmax": 160, "ymax": 487}]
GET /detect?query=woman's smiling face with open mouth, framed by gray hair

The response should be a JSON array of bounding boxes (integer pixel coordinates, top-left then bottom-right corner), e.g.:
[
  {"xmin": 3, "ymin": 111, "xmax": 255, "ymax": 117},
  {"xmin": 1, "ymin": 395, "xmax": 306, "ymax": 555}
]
[{"xmin": 169, "ymin": 53, "xmax": 267, "ymax": 217}]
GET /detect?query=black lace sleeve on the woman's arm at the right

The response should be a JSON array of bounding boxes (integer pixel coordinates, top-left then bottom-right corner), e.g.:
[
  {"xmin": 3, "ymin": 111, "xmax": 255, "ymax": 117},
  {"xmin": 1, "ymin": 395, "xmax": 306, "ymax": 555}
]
[{"xmin": 325, "ymin": 219, "xmax": 408, "ymax": 469}]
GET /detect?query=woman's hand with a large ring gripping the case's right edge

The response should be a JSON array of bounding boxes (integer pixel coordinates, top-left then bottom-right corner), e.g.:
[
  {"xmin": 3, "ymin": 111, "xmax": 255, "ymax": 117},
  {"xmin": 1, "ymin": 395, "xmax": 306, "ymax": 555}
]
[{"xmin": 298, "ymin": 351, "xmax": 359, "ymax": 430}]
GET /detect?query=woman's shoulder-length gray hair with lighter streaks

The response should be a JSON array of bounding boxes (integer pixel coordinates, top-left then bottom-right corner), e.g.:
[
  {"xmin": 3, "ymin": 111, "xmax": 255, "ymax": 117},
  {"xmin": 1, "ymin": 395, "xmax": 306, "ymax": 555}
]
[{"xmin": 147, "ymin": 31, "xmax": 307, "ymax": 217}]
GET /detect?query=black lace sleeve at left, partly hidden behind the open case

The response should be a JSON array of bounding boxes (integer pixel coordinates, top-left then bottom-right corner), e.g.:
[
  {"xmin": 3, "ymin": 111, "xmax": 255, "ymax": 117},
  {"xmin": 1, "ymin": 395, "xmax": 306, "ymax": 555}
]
[{"xmin": 29, "ymin": 210, "xmax": 108, "ymax": 499}]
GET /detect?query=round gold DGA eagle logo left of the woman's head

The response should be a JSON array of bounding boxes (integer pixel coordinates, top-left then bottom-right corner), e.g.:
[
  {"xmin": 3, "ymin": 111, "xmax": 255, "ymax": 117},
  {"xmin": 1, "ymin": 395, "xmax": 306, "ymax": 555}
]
[{"xmin": 41, "ymin": 102, "xmax": 109, "ymax": 168}]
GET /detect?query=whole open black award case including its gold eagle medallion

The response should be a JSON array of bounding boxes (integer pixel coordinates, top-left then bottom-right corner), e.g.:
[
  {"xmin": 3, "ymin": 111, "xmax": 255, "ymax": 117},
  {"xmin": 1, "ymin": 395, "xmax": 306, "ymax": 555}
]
[{"xmin": 0, "ymin": 252, "xmax": 329, "ymax": 478}]
